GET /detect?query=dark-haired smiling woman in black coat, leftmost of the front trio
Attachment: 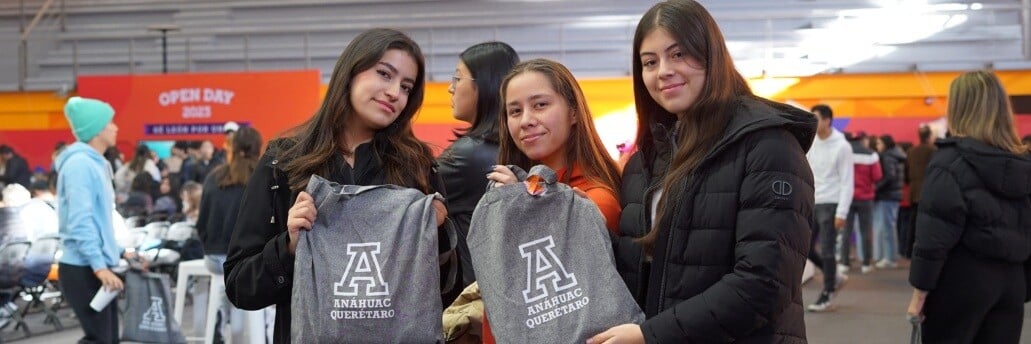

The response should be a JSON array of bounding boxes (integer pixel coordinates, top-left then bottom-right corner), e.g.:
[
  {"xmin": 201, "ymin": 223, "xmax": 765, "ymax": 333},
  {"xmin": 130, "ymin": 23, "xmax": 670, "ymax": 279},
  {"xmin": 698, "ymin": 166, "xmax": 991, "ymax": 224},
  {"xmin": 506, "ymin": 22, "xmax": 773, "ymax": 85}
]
[{"xmin": 225, "ymin": 29, "xmax": 446, "ymax": 343}]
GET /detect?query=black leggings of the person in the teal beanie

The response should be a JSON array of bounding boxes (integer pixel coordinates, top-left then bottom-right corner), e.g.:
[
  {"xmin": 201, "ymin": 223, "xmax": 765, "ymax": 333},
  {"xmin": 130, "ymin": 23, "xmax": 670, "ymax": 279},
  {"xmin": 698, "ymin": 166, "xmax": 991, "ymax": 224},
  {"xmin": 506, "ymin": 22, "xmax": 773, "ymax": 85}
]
[{"xmin": 58, "ymin": 263, "xmax": 119, "ymax": 344}]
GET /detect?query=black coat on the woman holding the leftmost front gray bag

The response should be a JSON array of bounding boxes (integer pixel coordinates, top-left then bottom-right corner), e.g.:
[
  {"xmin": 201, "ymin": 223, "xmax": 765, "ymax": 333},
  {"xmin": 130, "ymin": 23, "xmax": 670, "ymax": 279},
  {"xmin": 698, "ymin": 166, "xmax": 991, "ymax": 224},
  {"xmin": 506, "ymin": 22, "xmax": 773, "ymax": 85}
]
[{"xmin": 224, "ymin": 139, "xmax": 447, "ymax": 343}]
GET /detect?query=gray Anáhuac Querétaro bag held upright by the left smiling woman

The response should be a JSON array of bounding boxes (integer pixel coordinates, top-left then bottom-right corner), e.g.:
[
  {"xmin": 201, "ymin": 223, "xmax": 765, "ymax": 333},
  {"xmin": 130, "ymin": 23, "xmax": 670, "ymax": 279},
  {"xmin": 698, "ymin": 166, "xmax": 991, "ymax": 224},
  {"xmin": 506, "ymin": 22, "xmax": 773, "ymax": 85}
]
[{"xmin": 290, "ymin": 176, "xmax": 443, "ymax": 343}]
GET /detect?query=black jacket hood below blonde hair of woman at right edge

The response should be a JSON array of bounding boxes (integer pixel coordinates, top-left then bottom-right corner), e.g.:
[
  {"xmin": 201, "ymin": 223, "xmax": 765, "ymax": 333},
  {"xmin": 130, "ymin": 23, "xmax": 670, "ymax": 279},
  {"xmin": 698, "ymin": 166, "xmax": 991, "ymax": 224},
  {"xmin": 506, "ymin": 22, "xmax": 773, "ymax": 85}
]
[{"xmin": 936, "ymin": 138, "xmax": 1031, "ymax": 199}]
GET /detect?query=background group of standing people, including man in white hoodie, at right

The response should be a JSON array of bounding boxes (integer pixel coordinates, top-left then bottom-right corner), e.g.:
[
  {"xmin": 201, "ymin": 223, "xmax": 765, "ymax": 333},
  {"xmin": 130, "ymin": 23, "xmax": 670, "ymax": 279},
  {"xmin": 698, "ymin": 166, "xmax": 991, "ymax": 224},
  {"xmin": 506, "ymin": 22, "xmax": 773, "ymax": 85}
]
[{"xmin": 808, "ymin": 104, "xmax": 943, "ymax": 312}]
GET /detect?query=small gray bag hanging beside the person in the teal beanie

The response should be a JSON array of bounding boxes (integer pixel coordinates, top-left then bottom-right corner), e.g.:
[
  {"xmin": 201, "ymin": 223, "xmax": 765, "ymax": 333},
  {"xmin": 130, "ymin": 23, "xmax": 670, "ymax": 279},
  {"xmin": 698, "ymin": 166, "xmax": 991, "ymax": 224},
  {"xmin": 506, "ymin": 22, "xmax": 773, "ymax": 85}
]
[{"xmin": 122, "ymin": 270, "xmax": 187, "ymax": 343}]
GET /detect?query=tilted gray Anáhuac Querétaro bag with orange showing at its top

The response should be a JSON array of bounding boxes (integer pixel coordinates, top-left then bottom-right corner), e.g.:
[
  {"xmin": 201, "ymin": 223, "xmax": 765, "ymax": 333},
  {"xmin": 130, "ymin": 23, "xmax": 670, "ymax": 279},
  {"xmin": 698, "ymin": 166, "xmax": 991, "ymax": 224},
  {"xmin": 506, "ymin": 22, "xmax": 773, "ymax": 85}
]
[{"xmin": 468, "ymin": 165, "xmax": 644, "ymax": 343}]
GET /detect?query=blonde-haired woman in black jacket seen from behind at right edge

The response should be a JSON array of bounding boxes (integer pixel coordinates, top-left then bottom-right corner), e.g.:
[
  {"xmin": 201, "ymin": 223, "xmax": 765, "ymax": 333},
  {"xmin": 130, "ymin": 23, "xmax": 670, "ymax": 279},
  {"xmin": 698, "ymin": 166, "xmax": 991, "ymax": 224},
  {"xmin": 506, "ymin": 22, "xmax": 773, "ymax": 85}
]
[{"xmin": 908, "ymin": 71, "xmax": 1031, "ymax": 343}]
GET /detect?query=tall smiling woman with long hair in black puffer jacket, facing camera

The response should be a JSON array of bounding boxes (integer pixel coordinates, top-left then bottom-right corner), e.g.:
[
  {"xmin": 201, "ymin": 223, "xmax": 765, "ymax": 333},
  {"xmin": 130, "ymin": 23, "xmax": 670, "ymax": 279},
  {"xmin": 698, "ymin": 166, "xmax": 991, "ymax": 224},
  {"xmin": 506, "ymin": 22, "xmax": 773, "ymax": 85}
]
[{"xmin": 588, "ymin": 0, "xmax": 817, "ymax": 343}]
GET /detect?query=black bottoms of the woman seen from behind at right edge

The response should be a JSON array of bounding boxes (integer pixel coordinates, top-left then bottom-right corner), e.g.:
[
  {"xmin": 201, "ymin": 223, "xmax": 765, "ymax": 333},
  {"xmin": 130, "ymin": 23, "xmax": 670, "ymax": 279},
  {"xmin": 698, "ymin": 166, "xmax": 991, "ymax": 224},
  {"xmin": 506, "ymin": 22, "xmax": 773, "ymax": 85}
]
[{"xmin": 923, "ymin": 246, "xmax": 1026, "ymax": 344}]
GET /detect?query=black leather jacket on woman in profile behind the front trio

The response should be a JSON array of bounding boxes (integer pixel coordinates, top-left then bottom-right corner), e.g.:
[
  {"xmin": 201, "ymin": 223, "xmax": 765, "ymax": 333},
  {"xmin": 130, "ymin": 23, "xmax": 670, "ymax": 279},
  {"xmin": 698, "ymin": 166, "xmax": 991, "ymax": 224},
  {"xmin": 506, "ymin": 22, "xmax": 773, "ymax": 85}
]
[{"xmin": 437, "ymin": 136, "xmax": 498, "ymax": 288}]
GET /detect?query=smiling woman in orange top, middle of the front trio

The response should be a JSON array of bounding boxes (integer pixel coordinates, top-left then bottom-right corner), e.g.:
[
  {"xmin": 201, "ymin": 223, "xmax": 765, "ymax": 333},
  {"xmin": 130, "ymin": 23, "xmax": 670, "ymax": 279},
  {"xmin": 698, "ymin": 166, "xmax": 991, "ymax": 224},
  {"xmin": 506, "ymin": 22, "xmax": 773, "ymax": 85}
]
[{"xmin": 484, "ymin": 59, "xmax": 620, "ymax": 343}]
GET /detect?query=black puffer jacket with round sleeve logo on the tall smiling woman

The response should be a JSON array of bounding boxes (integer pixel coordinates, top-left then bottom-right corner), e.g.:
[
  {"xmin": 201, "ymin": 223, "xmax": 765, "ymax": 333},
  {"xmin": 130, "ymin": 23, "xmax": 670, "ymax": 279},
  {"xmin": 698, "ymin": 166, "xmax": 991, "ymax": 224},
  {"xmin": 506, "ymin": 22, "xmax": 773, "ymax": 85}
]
[{"xmin": 616, "ymin": 98, "xmax": 817, "ymax": 343}]
